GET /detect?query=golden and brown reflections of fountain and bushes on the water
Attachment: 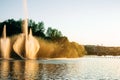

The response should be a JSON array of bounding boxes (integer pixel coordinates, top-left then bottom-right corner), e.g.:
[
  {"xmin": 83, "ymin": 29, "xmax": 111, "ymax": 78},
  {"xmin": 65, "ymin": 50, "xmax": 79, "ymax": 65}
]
[{"xmin": 0, "ymin": 60, "xmax": 79, "ymax": 80}]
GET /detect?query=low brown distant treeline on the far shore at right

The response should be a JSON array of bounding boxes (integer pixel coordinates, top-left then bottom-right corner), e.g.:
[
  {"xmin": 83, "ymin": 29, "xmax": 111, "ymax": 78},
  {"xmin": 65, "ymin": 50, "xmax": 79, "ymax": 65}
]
[{"xmin": 85, "ymin": 45, "xmax": 120, "ymax": 56}]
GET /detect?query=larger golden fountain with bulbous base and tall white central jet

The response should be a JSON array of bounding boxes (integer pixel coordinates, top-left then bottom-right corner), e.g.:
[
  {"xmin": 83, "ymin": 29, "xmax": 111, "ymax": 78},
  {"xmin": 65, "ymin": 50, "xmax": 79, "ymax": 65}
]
[{"xmin": 13, "ymin": 0, "xmax": 40, "ymax": 59}]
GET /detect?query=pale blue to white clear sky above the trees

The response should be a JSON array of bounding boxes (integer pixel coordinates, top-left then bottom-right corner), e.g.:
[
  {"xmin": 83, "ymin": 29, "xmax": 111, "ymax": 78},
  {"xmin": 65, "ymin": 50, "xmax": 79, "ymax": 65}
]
[{"xmin": 0, "ymin": 0, "xmax": 120, "ymax": 46}]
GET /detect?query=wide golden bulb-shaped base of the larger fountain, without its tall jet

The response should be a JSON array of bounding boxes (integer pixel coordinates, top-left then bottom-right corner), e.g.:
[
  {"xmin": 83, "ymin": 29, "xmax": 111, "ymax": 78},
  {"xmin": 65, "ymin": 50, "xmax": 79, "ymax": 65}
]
[{"xmin": 13, "ymin": 22, "xmax": 40, "ymax": 59}]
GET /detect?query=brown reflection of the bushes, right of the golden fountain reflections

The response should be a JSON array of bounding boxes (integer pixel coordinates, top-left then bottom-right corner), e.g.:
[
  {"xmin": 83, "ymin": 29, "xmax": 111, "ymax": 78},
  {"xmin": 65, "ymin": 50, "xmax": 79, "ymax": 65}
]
[{"xmin": 41, "ymin": 64, "xmax": 80, "ymax": 80}]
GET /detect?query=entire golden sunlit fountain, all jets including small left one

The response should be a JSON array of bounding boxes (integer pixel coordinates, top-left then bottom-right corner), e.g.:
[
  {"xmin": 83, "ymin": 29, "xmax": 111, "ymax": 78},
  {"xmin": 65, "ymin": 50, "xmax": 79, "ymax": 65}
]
[{"xmin": 0, "ymin": 0, "xmax": 40, "ymax": 59}]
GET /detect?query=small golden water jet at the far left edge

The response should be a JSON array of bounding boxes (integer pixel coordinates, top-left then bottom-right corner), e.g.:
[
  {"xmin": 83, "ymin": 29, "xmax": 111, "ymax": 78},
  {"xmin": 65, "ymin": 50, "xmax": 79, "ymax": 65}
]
[{"xmin": 0, "ymin": 25, "xmax": 11, "ymax": 59}]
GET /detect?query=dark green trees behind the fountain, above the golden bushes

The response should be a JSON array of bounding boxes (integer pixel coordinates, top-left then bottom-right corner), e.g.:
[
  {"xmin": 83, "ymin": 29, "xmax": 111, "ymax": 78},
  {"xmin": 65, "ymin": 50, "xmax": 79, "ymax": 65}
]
[{"xmin": 0, "ymin": 19, "xmax": 62, "ymax": 39}]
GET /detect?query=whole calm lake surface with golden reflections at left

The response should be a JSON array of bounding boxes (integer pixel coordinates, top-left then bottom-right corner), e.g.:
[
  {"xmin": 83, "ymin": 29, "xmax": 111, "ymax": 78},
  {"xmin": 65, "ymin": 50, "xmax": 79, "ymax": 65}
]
[{"xmin": 0, "ymin": 56, "xmax": 120, "ymax": 80}]
